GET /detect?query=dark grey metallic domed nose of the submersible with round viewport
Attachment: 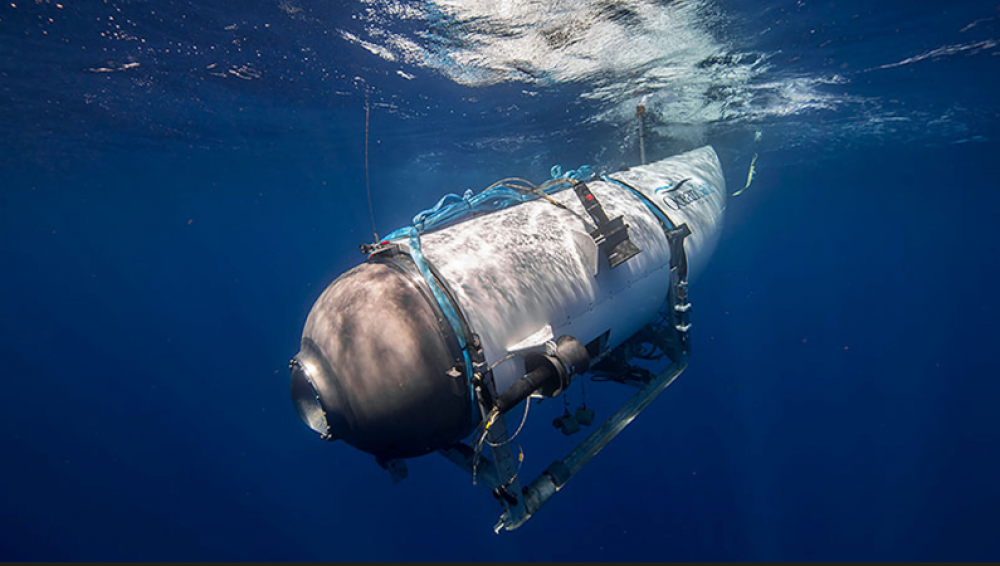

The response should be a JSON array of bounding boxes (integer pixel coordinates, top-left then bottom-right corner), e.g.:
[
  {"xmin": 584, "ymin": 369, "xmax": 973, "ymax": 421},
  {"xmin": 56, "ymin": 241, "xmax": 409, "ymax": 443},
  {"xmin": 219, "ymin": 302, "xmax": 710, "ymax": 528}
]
[{"xmin": 291, "ymin": 258, "xmax": 472, "ymax": 458}]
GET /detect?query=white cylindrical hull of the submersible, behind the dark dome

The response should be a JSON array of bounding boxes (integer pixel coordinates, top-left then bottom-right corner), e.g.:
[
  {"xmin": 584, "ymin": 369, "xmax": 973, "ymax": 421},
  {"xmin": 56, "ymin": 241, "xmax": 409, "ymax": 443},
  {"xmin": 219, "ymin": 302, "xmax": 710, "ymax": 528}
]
[{"xmin": 408, "ymin": 146, "xmax": 726, "ymax": 393}]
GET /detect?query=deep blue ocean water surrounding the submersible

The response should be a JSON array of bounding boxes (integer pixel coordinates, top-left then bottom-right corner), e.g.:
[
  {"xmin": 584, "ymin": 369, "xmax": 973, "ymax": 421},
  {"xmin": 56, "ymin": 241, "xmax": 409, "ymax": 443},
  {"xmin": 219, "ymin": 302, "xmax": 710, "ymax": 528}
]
[{"xmin": 0, "ymin": 0, "xmax": 1000, "ymax": 561}]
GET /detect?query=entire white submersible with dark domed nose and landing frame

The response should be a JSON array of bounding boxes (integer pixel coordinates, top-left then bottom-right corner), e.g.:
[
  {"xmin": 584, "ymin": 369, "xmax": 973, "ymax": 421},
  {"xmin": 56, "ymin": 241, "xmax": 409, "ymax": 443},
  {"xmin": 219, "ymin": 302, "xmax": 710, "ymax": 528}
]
[{"xmin": 290, "ymin": 146, "xmax": 726, "ymax": 532}]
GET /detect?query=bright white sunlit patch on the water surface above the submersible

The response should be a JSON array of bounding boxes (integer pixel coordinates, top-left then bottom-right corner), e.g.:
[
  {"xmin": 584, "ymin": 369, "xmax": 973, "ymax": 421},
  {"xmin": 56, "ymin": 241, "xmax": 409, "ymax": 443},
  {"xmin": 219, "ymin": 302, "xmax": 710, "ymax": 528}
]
[{"xmin": 341, "ymin": 0, "xmax": 843, "ymax": 139}]
